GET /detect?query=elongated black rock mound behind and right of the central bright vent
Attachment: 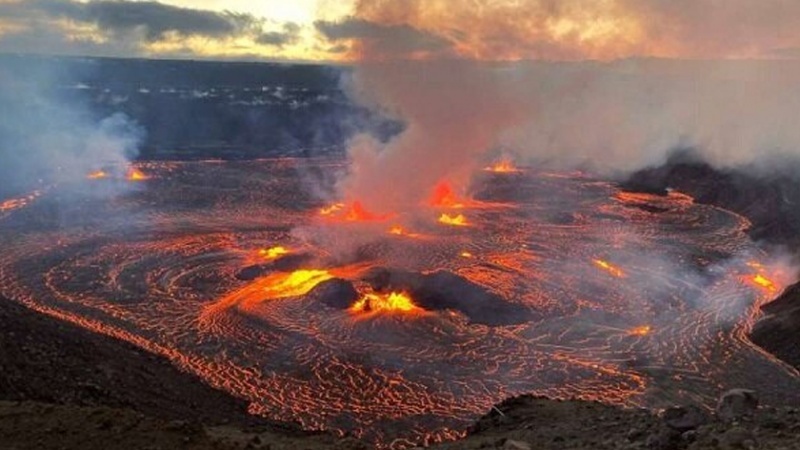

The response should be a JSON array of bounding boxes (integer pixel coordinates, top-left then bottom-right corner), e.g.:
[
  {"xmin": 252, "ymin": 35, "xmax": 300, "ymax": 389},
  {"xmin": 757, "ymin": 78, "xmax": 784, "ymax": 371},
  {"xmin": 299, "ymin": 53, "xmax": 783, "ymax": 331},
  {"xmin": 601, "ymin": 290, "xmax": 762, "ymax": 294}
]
[{"xmin": 364, "ymin": 268, "xmax": 532, "ymax": 326}]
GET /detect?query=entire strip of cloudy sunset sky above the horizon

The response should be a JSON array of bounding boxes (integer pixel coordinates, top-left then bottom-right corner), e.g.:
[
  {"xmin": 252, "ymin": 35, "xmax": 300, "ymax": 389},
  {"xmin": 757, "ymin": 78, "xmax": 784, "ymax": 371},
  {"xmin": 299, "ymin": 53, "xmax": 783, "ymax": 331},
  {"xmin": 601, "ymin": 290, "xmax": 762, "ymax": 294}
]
[{"xmin": 0, "ymin": 0, "xmax": 800, "ymax": 62}]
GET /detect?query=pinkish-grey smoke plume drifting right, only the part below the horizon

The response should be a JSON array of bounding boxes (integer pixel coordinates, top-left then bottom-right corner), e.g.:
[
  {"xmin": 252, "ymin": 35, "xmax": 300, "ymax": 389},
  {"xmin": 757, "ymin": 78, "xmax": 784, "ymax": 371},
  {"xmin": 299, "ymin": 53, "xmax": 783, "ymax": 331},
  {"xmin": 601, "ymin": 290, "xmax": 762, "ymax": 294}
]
[{"xmin": 341, "ymin": 60, "xmax": 800, "ymax": 210}]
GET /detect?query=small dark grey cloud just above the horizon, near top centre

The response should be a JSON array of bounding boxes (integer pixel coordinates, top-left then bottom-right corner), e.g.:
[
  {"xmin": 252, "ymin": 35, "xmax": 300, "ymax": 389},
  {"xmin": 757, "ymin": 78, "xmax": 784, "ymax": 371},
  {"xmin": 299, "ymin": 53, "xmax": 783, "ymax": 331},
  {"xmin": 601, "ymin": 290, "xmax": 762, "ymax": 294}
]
[{"xmin": 314, "ymin": 17, "xmax": 451, "ymax": 57}]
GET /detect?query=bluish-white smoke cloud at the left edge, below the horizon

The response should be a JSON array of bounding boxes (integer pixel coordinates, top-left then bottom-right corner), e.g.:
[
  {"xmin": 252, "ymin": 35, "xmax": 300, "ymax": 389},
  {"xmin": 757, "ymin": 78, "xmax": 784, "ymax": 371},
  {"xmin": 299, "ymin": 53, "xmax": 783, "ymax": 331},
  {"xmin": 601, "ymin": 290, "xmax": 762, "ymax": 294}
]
[{"xmin": 0, "ymin": 60, "xmax": 143, "ymax": 197}]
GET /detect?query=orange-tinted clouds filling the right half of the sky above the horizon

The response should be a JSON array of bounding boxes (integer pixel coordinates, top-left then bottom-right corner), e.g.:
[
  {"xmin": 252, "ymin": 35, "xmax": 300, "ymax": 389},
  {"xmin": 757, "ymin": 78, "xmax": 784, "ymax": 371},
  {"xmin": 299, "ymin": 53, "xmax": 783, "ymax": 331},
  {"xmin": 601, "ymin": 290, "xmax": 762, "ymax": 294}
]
[{"xmin": 353, "ymin": 0, "xmax": 800, "ymax": 61}]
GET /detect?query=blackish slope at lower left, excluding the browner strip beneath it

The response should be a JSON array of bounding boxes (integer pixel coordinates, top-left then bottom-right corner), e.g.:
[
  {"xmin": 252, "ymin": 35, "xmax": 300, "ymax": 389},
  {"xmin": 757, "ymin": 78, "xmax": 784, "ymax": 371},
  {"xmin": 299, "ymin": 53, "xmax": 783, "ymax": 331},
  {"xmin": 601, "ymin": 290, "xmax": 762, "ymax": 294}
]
[{"xmin": 0, "ymin": 298, "xmax": 276, "ymax": 424}]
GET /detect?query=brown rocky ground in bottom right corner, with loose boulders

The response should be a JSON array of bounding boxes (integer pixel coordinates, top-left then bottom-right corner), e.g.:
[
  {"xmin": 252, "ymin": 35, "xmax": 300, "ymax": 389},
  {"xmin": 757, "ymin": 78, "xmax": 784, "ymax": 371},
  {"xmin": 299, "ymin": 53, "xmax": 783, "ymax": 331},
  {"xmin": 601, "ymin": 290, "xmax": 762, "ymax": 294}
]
[{"xmin": 439, "ymin": 391, "xmax": 800, "ymax": 450}]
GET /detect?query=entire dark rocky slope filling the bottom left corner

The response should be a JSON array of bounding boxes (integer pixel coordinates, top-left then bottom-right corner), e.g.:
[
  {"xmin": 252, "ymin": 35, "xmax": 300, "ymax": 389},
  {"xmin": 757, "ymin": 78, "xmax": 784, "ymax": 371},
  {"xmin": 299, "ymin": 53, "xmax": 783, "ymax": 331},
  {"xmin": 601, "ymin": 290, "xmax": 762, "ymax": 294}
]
[{"xmin": 0, "ymin": 298, "xmax": 358, "ymax": 450}]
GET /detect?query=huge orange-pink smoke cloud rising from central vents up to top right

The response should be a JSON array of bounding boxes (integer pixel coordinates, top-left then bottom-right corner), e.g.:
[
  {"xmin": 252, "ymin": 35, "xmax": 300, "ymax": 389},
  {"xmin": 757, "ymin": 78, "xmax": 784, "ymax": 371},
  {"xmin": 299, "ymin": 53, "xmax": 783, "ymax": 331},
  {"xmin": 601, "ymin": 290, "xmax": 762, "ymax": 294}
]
[{"xmin": 317, "ymin": 0, "xmax": 800, "ymax": 214}]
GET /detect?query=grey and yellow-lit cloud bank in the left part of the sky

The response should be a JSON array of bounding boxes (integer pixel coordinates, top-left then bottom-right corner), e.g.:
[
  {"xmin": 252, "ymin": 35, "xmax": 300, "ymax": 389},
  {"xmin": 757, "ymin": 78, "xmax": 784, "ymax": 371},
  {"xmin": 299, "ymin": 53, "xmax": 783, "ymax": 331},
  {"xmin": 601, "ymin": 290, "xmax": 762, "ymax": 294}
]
[{"xmin": 0, "ymin": 0, "xmax": 316, "ymax": 59}]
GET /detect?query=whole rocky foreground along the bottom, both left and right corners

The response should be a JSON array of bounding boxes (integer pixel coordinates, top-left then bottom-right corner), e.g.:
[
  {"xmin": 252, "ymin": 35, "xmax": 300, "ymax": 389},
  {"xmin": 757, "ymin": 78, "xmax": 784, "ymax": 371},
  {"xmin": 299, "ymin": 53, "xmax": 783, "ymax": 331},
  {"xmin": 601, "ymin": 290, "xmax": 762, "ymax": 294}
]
[{"xmin": 0, "ymin": 299, "xmax": 800, "ymax": 450}]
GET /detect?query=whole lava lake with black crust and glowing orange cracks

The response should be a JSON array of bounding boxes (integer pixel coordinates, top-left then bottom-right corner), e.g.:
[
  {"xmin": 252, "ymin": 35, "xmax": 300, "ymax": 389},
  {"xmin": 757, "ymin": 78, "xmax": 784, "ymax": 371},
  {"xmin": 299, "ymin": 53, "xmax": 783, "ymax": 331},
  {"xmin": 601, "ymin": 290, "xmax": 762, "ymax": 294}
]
[{"xmin": 0, "ymin": 159, "xmax": 800, "ymax": 448}]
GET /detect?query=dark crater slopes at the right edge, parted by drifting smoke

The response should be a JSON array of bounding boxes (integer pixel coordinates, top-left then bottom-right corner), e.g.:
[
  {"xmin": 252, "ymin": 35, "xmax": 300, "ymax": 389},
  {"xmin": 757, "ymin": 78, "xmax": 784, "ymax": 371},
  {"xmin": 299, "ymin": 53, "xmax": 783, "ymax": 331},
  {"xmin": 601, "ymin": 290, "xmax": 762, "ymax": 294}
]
[{"xmin": 622, "ymin": 153, "xmax": 800, "ymax": 368}]
